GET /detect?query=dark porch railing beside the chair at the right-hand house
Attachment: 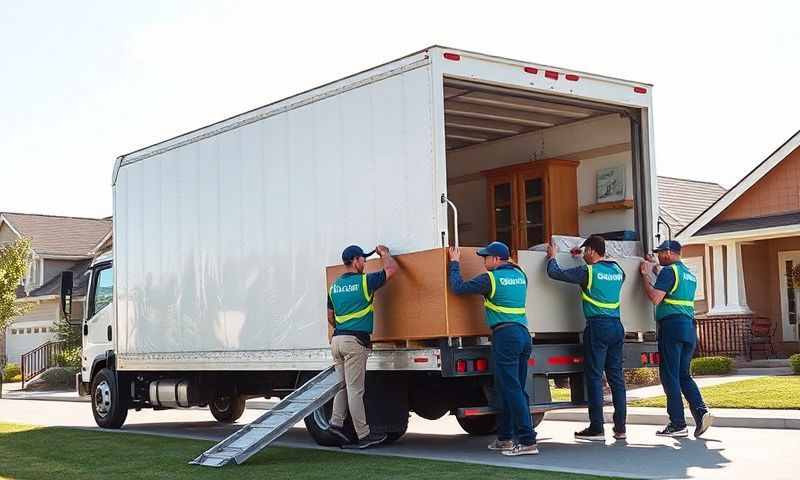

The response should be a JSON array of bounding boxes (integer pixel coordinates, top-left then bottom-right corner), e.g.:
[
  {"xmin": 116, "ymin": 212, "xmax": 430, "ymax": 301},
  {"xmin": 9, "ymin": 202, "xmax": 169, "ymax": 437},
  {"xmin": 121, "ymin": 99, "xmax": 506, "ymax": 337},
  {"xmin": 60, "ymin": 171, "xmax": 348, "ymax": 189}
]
[{"xmin": 696, "ymin": 316, "xmax": 753, "ymax": 357}]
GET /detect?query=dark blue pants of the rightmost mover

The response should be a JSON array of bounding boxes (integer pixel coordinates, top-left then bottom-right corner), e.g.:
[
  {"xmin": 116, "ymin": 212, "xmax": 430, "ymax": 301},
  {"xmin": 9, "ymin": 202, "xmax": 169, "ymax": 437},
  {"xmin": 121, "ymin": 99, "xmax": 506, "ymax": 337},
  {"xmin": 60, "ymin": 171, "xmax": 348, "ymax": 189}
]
[{"xmin": 658, "ymin": 315, "xmax": 706, "ymax": 428}]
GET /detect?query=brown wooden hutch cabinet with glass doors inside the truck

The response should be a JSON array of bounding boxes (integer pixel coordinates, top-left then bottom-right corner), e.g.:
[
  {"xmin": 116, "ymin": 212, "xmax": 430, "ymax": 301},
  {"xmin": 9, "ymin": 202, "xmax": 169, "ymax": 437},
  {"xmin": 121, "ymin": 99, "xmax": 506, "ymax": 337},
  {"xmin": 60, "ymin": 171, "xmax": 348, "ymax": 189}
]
[{"xmin": 481, "ymin": 159, "xmax": 579, "ymax": 251}]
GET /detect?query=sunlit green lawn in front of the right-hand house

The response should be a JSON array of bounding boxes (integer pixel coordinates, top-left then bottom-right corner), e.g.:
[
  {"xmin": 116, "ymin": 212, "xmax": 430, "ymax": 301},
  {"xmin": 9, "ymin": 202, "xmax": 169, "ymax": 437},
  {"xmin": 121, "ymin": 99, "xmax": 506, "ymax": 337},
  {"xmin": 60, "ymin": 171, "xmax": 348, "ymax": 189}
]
[{"xmin": 629, "ymin": 376, "xmax": 800, "ymax": 409}]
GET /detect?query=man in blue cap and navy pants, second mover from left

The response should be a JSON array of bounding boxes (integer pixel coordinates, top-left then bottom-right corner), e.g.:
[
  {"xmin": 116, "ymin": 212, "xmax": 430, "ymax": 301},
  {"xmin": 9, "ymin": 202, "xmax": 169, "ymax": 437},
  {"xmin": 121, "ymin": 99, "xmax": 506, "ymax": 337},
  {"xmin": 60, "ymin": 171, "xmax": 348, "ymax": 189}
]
[{"xmin": 448, "ymin": 242, "xmax": 539, "ymax": 456}]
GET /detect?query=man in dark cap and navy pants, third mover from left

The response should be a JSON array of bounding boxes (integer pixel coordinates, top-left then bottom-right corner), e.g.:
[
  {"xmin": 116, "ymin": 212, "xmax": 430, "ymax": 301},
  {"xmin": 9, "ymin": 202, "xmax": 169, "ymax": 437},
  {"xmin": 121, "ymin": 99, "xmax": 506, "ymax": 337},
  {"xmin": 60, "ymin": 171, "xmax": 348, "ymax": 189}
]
[{"xmin": 547, "ymin": 235, "xmax": 627, "ymax": 441}]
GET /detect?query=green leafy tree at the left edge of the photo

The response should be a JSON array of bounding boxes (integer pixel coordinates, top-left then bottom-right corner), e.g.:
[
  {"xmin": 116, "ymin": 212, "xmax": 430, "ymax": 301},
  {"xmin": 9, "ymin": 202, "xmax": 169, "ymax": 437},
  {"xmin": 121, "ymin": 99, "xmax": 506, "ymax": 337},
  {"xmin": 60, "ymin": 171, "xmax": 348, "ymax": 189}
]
[{"xmin": 0, "ymin": 238, "xmax": 31, "ymax": 394}]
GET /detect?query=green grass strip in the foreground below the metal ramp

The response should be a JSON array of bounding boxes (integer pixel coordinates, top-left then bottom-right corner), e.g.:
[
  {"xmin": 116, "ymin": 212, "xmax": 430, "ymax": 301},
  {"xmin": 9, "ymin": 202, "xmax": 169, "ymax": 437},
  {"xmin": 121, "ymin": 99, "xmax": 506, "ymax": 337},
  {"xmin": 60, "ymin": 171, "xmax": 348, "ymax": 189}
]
[{"xmin": 0, "ymin": 423, "xmax": 624, "ymax": 480}]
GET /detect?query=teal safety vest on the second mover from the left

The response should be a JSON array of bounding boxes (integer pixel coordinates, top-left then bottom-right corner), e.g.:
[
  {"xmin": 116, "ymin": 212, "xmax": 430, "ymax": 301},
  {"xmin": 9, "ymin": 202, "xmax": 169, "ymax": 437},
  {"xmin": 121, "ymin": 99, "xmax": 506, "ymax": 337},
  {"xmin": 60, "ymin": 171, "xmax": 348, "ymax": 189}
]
[{"xmin": 483, "ymin": 267, "xmax": 528, "ymax": 328}]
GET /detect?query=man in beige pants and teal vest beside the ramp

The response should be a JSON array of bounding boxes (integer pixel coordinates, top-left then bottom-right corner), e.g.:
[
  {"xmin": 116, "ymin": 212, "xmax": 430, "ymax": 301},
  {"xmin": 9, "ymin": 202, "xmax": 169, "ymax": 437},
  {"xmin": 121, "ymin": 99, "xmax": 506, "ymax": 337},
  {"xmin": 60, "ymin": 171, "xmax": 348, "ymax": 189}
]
[{"xmin": 328, "ymin": 245, "xmax": 398, "ymax": 449}]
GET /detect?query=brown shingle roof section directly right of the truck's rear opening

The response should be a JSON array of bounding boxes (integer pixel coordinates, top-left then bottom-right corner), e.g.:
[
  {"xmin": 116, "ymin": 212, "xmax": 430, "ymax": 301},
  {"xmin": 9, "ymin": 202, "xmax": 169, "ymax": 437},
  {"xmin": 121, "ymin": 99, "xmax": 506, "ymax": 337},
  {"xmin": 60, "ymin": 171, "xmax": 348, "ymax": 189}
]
[{"xmin": 658, "ymin": 176, "xmax": 727, "ymax": 233}]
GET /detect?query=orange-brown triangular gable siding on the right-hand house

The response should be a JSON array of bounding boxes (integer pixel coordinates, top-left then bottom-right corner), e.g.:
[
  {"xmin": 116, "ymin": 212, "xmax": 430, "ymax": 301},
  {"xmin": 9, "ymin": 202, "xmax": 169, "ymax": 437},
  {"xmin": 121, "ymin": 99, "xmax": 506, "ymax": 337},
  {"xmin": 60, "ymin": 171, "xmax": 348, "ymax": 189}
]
[{"xmin": 711, "ymin": 149, "xmax": 800, "ymax": 224}]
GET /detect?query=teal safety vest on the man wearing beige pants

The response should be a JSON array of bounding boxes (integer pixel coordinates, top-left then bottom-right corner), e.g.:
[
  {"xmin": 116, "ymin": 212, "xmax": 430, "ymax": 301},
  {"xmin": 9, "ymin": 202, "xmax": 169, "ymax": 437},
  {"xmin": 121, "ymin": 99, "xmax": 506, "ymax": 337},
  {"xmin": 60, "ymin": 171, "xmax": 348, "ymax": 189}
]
[{"xmin": 328, "ymin": 273, "xmax": 374, "ymax": 333}]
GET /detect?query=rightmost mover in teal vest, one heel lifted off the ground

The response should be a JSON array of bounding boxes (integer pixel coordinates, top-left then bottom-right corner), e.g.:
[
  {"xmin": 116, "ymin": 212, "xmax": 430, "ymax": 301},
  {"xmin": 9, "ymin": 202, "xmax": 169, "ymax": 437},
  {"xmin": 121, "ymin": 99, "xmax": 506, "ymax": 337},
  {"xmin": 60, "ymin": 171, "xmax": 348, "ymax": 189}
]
[{"xmin": 640, "ymin": 240, "xmax": 712, "ymax": 437}]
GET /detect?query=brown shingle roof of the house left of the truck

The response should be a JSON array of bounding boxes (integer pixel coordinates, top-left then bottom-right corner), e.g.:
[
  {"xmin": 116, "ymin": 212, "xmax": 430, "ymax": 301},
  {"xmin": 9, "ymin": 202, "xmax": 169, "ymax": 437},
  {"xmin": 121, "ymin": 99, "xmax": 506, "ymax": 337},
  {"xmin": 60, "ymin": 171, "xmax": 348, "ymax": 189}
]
[{"xmin": 1, "ymin": 212, "xmax": 111, "ymax": 256}]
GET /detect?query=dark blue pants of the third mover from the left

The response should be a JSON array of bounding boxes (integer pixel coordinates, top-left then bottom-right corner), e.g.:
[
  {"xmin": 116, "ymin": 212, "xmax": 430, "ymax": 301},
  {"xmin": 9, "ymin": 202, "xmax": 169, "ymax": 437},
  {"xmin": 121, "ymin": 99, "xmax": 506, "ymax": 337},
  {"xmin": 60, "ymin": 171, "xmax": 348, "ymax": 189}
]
[{"xmin": 583, "ymin": 317, "xmax": 627, "ymax": 432}]
